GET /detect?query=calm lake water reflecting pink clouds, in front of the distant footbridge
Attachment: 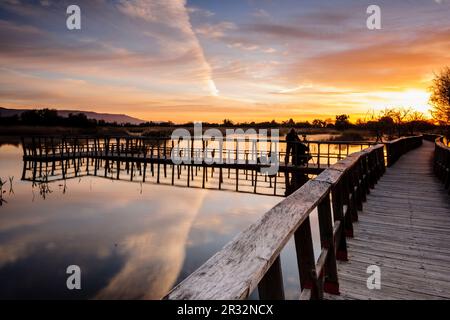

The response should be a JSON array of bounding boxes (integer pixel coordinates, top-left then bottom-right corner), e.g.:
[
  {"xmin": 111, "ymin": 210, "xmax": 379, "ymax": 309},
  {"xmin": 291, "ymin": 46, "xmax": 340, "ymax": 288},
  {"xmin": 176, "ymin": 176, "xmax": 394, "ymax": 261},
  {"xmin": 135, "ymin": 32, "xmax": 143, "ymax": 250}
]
[{"xmin": 0, "ymin": 136, "xmax": 330, "ymax": 299}]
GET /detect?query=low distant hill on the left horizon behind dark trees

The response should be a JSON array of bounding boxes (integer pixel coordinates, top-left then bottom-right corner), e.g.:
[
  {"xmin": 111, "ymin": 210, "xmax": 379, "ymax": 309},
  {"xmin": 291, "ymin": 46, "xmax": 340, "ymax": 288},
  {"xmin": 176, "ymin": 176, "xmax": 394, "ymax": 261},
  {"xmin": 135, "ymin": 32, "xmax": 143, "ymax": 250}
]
[{"xmin": 0, "ymin": 108, "xmax": 145, "ymax": 124}]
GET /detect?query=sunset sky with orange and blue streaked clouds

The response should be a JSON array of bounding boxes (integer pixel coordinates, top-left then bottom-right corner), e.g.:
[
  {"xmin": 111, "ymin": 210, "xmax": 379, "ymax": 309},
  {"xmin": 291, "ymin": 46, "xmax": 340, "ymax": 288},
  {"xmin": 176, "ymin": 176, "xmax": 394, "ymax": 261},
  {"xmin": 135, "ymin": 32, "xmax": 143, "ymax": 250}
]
[{"xmin": 0, "ymin": 0, "xmax": 450, "ymax": 122}]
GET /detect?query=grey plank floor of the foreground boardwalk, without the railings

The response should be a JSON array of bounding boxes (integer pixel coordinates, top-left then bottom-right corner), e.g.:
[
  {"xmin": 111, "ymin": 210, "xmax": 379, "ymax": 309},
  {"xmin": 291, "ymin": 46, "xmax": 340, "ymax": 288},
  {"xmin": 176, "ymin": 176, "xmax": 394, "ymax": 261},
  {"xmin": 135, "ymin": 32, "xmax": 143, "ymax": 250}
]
[{"xmin": 326, "ymin": 141, "xmax": 450, "ymax": 299}]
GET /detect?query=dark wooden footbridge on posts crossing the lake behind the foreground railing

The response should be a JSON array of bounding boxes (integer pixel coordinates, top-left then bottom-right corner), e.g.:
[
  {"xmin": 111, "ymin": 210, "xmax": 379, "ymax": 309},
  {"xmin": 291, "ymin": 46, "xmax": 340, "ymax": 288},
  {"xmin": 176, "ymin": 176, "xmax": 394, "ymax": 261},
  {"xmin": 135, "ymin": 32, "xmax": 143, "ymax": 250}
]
[{"xmin": 22, "ymin": 136, "xmax": 373, "ymax": 196}]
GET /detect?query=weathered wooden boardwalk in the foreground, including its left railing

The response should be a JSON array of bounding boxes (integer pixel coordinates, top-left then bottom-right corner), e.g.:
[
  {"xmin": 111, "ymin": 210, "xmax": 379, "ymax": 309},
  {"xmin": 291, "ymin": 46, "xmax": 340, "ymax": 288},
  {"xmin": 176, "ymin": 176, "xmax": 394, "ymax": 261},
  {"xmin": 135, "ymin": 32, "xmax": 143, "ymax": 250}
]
[{"xmin": 166, "ymin": 137, "xmax": 450, "ymax": 299}]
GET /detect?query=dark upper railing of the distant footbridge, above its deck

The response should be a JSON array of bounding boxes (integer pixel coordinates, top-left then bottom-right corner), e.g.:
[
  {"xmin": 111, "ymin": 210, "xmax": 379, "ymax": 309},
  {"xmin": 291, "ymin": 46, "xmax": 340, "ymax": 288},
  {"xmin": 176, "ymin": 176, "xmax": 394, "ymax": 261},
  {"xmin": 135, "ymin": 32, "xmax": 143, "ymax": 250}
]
[{"xmin": 22, "ymin": 136, "xmax": 376, "ymax": 169}]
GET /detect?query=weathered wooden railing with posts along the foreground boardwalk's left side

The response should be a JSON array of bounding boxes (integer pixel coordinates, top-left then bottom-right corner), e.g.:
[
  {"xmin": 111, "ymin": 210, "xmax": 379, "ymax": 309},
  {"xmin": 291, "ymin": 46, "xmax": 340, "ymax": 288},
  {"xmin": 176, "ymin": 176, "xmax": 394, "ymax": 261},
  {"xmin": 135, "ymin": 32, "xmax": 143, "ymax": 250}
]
[{"xmin": 165, "ymin": 144, "xmax": 385, "ymax": 299}]
